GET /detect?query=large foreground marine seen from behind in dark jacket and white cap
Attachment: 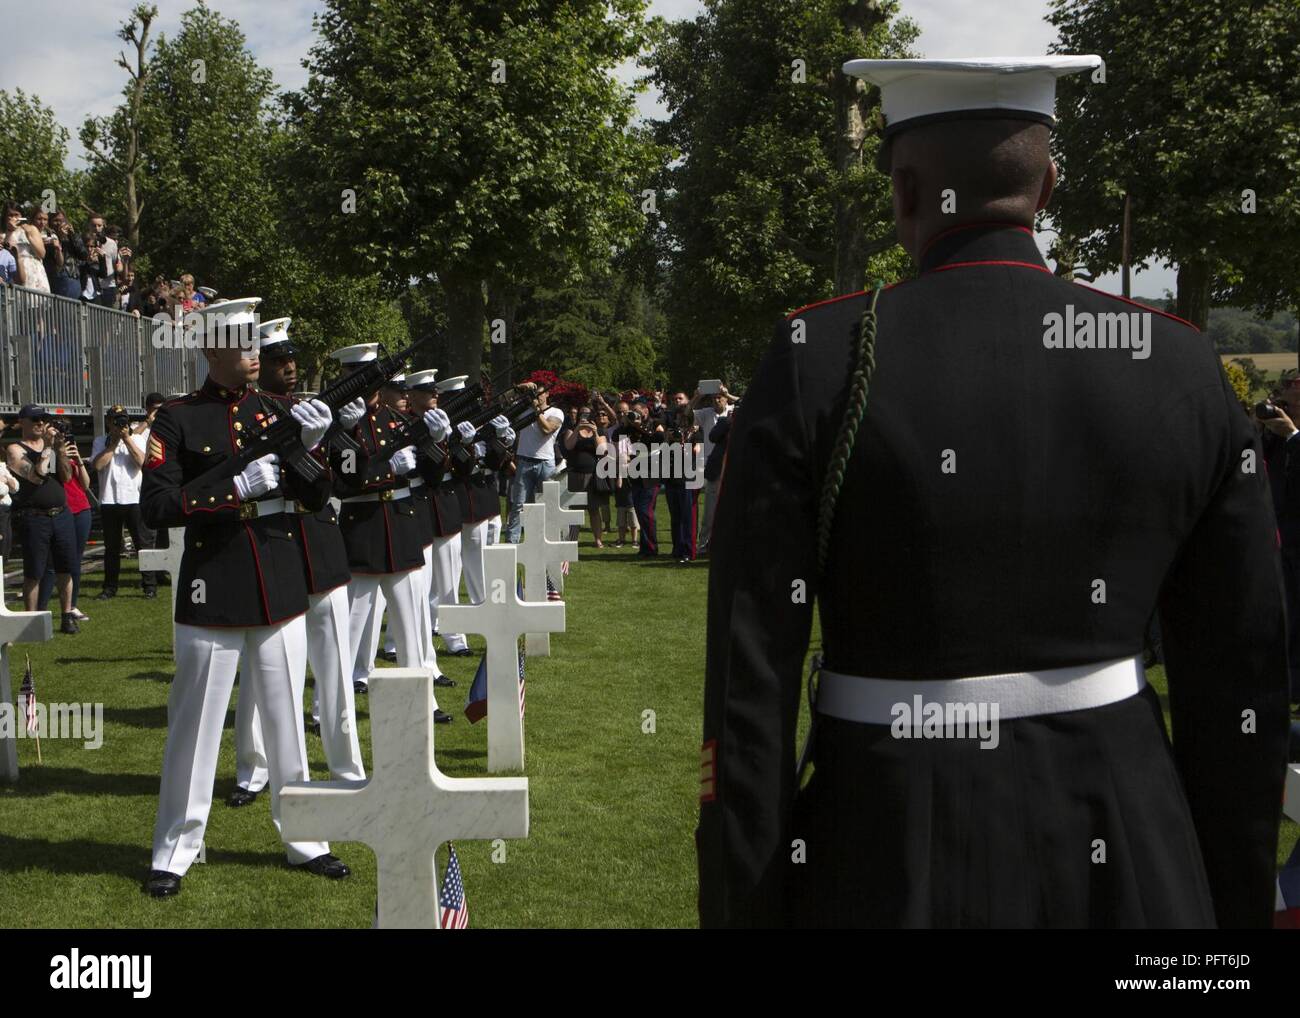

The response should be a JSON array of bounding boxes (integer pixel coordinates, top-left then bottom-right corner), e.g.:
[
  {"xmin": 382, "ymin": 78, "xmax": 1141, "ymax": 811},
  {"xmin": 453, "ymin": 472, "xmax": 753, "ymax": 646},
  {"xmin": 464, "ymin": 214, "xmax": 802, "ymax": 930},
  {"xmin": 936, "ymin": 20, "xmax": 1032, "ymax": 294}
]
[{"xmin": 697, "ymin": 56, "xmax": 1287, "ymax": 927}]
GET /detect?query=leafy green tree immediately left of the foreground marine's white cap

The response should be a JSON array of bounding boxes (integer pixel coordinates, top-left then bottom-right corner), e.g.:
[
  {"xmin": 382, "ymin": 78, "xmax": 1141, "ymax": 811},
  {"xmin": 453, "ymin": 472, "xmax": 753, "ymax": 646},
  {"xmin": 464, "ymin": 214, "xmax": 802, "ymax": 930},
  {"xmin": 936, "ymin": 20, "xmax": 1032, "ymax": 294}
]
[{"xmin": 649, "ymin": 0, "xmax": 917, "ymax": 381}]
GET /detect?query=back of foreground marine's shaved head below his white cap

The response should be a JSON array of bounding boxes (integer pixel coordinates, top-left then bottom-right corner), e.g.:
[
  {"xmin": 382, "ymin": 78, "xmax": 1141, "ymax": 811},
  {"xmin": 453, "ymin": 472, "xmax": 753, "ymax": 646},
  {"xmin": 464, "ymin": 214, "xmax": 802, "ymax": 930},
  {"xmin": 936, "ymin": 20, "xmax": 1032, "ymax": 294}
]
[{"xmin": 885, "ymin": 120, "xmax": 1056, "ymax": 260}]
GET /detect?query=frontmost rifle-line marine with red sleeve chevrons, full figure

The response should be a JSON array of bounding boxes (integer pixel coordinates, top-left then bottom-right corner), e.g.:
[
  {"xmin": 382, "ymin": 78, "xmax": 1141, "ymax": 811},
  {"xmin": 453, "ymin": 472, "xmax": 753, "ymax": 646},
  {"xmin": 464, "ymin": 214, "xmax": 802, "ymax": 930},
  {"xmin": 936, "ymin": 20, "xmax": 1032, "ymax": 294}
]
[{"xmin": 140, "ymin": 298, "xmax": 348, "ymax": 897}]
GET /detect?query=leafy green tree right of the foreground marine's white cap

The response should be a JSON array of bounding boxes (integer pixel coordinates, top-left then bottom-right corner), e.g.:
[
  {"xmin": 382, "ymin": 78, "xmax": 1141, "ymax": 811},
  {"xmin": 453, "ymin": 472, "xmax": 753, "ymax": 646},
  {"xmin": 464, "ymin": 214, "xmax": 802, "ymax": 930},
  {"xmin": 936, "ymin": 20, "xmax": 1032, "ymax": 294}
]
[{"xmin": 1048, "ymin": 0, "xmax": 1300, "ymax": 328}]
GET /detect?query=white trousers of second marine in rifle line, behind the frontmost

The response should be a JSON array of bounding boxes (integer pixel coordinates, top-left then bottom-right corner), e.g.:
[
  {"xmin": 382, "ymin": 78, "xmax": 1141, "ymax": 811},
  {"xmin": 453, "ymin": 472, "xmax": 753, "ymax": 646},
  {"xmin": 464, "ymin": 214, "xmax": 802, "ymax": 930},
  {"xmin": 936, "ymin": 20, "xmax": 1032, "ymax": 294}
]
[{"xmin": 235, "ymin": 586, "xmax": 365, "ymax": 792}]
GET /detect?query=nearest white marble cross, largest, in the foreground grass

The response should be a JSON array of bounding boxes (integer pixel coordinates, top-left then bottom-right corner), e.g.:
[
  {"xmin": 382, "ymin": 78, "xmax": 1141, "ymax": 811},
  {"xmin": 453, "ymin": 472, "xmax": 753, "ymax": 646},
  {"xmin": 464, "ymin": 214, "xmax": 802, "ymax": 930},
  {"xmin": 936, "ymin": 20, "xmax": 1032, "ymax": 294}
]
[{"xmin": 280, "ymin": 668, "xmax": 528, "ymax": 930}]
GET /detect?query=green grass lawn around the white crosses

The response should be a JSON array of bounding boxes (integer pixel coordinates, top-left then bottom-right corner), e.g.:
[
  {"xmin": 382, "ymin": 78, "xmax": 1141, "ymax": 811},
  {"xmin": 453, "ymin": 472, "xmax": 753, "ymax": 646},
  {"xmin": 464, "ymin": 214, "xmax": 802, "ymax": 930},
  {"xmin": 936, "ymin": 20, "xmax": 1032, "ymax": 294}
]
[{"xmin": 0, "ymin": 502, "xmax": 1297, "ymax": 927}]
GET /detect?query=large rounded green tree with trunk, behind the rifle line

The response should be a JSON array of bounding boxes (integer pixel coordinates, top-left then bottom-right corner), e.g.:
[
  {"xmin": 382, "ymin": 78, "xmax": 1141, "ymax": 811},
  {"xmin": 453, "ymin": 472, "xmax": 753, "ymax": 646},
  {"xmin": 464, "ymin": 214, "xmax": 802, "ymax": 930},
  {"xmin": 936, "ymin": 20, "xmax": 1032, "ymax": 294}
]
[{"xmin": 287, "ymin": 0, "xmax": 655, "ymax": 373}]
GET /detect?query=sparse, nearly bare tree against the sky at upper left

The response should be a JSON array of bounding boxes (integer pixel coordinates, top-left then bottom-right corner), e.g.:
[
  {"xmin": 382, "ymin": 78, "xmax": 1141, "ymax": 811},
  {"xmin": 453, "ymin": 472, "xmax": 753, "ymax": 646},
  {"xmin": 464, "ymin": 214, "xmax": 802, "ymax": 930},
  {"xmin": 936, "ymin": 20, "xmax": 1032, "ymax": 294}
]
[{"xmin": 81, "ymin": 4, "xmax": 159, "ymax": 250}]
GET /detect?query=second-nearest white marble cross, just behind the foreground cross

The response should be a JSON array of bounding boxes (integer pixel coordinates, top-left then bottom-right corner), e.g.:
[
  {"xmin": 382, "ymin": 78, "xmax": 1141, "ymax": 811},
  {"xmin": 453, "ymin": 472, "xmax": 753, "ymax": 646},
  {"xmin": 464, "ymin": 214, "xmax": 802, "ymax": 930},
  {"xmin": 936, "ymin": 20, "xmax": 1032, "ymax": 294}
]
[{"xmin": 438, "ymin": 546, "xmax": 564, "ymax": 771}]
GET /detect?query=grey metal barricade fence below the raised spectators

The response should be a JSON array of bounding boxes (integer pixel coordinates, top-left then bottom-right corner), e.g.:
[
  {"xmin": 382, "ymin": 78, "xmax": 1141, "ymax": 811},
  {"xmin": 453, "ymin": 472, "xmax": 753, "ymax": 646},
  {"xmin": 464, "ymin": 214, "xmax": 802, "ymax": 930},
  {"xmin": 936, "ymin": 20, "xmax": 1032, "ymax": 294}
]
[{"xmin": 0, "ymin": 283, "xmax": 198, "ymax": 418}]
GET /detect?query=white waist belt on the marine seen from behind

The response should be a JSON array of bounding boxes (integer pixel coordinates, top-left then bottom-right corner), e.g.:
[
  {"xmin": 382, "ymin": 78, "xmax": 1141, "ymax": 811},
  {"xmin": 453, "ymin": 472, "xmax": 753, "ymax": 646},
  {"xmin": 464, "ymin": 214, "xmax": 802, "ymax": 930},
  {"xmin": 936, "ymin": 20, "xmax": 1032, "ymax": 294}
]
[{"xmin": 816, "ymin": 658, "xmax": 1147, "ymax": 724}]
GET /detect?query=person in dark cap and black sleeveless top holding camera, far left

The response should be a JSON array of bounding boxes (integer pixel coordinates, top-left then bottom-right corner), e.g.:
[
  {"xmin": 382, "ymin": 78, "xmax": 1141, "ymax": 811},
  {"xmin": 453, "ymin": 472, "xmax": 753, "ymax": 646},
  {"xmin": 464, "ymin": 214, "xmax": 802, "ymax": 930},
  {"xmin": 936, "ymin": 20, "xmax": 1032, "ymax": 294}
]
[{"xmin": 5, "ymin": 403, "xmax": 81, "ymax": 633}]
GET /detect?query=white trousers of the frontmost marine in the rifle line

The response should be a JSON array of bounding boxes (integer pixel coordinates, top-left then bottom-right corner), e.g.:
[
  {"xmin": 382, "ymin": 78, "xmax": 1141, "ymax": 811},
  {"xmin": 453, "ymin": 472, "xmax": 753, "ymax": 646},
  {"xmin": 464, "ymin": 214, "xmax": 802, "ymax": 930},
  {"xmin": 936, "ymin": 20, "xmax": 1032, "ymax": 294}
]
[{"xmin": 153, "ymin": 616, "xmax": 329, "ymax": 876}]
